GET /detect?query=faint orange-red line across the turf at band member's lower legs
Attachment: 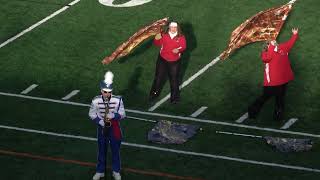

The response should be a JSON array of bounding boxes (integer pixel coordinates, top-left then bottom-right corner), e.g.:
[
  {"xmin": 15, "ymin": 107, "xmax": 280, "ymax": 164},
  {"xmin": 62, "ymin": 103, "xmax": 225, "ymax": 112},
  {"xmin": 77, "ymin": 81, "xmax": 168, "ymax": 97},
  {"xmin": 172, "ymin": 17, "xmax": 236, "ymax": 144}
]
[{"xmin": 0, "ymin": 149, "xmax": 200, "ymax": 180}]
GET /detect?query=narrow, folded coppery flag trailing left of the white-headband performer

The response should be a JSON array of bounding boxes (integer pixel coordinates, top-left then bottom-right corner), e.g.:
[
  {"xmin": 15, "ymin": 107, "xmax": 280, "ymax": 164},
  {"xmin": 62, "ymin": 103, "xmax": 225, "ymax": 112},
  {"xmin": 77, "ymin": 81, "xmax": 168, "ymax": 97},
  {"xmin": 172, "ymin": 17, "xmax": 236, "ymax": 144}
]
[{"xmin": 102, "ymin": 17, "xmax": 168, "ymax": 64}]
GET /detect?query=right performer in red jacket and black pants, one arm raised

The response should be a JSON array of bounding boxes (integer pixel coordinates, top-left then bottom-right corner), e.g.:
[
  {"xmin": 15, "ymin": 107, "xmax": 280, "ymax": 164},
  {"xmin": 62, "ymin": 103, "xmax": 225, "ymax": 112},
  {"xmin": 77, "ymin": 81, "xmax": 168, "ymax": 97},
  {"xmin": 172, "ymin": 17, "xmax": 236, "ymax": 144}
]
[{"xmin": 248, "ymin": 28, "xmax": 298, "ymax": 121}]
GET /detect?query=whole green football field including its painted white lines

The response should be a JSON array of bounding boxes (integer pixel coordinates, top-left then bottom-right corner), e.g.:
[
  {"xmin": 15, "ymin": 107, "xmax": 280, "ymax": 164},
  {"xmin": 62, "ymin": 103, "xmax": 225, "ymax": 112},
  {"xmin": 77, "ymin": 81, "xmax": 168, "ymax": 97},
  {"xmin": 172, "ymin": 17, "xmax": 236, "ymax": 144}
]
[{"xmin": 0, "ymin": 0, "xmax": 320, "ymax": 180}]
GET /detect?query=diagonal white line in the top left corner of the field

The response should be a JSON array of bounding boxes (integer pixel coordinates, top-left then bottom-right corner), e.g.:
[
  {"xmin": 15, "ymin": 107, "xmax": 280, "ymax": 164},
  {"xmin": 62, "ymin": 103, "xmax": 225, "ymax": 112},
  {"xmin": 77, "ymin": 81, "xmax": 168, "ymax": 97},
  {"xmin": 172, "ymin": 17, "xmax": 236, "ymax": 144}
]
[{"xmin": 0, "ymin": 0, "xmax": 80, "ymax": 49}]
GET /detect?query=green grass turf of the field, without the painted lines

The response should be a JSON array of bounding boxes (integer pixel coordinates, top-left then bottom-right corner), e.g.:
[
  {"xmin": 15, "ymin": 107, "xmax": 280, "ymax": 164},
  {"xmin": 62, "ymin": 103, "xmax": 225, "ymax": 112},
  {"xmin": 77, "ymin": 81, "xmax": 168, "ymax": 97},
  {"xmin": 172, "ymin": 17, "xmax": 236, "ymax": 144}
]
[{"xmin": 0, "ymin": 0, "xmax": 320, "ymax": 179}]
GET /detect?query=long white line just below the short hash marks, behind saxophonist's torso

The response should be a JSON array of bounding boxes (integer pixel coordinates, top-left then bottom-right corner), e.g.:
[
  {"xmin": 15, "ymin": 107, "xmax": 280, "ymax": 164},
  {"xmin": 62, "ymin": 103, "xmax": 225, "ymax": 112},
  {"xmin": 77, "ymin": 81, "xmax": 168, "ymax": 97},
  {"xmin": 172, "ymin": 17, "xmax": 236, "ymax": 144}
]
[{"xmin": 0, "ymin": 92, "xmax": 320, "ymax": 138}]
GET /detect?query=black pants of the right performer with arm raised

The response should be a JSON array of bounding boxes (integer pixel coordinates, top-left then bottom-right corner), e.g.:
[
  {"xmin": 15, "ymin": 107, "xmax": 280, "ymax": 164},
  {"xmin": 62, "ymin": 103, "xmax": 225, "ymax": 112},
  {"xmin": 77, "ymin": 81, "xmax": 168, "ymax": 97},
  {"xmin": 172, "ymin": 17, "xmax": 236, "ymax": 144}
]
[{"xmin": 248, "ymin": 83, "xmax": 287, "ymax": 120}]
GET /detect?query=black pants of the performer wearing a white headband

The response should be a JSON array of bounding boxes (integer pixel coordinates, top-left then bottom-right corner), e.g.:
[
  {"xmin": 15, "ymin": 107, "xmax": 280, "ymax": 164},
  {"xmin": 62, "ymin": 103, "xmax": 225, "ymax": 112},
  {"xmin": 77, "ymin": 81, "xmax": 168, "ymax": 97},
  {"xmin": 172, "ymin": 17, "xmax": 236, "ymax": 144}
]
[{"xmin": 150, "ymin": 55, "xmax": 180, "ymax": 102}]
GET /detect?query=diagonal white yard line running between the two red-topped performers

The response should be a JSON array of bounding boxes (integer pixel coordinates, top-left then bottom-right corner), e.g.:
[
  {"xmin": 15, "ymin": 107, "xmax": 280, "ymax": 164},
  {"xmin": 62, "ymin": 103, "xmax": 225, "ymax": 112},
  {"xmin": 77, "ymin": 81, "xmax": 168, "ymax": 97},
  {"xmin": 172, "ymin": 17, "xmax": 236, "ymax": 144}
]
[{"xmin": 148, "ymin": 56, "xmax": 220, "ymax": 111}]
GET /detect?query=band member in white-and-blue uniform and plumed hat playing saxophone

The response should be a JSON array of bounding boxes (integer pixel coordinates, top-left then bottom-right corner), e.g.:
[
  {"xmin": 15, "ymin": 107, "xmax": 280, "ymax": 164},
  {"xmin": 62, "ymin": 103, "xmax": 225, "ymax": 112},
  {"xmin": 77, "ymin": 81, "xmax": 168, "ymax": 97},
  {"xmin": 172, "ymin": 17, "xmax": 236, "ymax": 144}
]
[{"xmin": 89, "ymin": 71, "xmax": 126, "ymax": 180}]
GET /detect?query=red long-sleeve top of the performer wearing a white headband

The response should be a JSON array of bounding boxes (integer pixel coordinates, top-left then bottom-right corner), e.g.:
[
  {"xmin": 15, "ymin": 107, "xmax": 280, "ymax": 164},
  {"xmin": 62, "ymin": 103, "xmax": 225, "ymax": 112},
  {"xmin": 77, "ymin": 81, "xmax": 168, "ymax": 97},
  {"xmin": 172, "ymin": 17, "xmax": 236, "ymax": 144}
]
[{"xmin": 153, "ymin": 33, "xmax": 187, "ymax": 61}]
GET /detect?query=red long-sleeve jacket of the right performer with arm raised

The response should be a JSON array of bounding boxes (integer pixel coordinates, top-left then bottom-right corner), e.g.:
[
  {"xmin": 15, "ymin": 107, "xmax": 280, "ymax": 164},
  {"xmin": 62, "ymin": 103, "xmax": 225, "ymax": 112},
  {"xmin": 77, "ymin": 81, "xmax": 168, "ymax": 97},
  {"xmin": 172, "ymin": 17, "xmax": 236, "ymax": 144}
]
[{"xmin": 261, "ymin": 34, "xmax": 298, "ymax": 86}]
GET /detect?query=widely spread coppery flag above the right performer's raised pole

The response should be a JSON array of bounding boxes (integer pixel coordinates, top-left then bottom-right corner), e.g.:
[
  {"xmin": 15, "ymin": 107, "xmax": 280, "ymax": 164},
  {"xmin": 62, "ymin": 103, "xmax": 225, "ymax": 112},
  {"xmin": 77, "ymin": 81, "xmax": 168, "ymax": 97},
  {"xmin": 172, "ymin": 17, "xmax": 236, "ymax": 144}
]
[{"xmin": 220, "ymin": 0, "xmax": 296, "ymax": 60}]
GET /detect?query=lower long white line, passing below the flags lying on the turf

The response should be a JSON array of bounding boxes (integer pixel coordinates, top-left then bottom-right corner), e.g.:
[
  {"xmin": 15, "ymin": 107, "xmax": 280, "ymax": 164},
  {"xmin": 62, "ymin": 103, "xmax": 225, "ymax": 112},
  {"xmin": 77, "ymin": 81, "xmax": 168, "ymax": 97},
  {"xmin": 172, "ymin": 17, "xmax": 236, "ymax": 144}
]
[{"xmin": 0, "ymin": 125, "xmax": 320, "ymax": 173}]
